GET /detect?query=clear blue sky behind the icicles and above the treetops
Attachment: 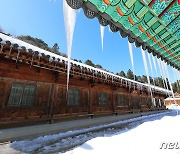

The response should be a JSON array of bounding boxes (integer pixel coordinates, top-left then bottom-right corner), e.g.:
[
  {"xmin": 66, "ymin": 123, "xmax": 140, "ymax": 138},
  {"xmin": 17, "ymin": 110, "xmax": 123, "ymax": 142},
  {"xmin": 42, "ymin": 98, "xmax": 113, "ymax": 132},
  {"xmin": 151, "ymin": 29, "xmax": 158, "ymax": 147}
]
[{"xmin": 0, "ymin": 0, "xmax": 177, "ymax": 81}]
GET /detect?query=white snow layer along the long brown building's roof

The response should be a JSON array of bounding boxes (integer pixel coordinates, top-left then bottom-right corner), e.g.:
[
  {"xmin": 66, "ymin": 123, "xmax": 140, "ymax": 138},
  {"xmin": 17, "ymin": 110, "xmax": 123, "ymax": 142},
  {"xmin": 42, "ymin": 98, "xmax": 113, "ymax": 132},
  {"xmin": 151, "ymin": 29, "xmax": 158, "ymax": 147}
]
[{"xmin": 0, "ymin": 33, "xmax": 171, "ymax": 94}]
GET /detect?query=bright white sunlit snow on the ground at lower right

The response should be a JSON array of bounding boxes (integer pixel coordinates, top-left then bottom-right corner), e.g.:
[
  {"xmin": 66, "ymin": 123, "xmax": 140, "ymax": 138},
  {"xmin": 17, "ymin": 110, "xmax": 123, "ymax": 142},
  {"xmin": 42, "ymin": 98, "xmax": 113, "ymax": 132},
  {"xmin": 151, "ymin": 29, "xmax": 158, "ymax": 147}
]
[{"xmin": 66, "ymin": 106, "xmax": 180, "ymax": 154}]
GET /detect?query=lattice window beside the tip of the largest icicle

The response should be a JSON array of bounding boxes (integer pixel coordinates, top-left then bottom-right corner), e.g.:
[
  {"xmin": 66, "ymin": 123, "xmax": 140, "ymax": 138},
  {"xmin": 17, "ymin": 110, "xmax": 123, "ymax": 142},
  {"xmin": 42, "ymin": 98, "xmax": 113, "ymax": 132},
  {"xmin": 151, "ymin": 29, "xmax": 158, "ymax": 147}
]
[{"xmin": 67, "ymin": 89, "xmax": 80, "ymax": 106}]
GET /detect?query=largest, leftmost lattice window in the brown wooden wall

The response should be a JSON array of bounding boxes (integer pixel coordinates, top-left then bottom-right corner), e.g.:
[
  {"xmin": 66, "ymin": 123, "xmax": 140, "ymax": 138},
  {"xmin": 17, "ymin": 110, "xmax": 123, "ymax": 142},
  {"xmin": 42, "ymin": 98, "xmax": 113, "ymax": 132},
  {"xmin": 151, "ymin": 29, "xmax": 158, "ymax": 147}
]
[{"xmin": 7, "ymin": 83, "xmax": 36, "ymax": 107}]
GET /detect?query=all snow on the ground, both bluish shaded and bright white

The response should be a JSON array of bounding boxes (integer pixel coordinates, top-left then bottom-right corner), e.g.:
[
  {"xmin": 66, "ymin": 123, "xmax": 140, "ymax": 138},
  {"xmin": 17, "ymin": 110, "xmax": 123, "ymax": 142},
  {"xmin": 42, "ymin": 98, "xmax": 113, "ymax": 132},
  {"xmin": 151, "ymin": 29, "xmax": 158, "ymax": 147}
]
[{"xmin": 0, "ymin": 106, "xmax": 180, "ymax": 154}]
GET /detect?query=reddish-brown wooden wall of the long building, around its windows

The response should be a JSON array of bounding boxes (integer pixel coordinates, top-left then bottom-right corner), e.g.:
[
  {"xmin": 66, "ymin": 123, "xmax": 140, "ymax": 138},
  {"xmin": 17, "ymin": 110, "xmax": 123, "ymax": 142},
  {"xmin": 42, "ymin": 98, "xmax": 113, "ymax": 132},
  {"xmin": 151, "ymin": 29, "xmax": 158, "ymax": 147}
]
[{"xmin": 0, "ymin": 58, "xmax": 166, "ymax": 127}]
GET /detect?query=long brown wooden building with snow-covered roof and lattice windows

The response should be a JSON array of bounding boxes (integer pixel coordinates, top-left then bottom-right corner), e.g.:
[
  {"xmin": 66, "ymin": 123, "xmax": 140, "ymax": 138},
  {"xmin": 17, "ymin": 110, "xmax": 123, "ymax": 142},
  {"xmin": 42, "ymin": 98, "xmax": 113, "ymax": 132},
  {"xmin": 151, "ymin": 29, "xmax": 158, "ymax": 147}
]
[{"xmin": 0, "ymin": 33, "xmax": 171, "ymax": 127}]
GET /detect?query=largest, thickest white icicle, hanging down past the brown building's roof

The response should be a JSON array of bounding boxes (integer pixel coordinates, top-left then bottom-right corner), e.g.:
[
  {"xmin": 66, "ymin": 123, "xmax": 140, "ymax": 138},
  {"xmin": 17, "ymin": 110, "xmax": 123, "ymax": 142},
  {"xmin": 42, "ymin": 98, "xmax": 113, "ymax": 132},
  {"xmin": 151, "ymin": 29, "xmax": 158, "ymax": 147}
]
[{"xmin": 63, "ymin": 0, "xmax": 76, "ymax": 91}]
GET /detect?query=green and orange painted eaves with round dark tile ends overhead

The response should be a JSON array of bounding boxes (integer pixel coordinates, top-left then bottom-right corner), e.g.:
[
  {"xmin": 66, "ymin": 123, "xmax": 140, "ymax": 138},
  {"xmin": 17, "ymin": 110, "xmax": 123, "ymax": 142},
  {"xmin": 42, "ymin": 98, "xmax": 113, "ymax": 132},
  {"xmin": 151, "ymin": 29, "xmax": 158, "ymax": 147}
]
[{"xmin": 66, "ymin": 0, "xmax": 180, "ymax": 70}]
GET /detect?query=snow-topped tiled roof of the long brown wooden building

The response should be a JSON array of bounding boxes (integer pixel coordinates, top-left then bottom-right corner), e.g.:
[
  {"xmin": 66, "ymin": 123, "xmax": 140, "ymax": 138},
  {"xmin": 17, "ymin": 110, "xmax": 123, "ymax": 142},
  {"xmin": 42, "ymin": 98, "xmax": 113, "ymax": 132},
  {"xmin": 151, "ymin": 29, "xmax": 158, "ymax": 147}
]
[{"xmin": 0, "ymin": 33, "xmax": 171, "ymax": 94}]
